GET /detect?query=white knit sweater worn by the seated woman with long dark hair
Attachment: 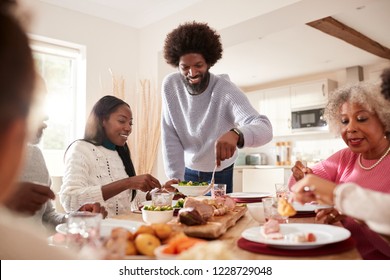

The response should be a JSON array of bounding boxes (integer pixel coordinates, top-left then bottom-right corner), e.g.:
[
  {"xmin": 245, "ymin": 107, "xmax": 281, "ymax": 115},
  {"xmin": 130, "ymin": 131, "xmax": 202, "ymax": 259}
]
[{"xmin": 60, "ymin": 141, "xmax": 146, "ymax": 217}]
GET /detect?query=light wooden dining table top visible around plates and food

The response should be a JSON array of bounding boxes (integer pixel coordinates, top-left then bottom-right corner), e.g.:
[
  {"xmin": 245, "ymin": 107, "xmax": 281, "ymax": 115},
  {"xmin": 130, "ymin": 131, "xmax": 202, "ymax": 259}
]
[{"xmin": 117, "ymin": 208, "xmax": 362, "ymax": 260}]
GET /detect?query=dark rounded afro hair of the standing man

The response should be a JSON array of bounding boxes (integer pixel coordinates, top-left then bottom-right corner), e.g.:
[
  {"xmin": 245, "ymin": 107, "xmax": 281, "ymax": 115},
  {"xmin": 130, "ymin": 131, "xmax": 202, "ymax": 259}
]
[{"xmin": 164, "ymin": 21, "xmax": 223, "ymax": 67}]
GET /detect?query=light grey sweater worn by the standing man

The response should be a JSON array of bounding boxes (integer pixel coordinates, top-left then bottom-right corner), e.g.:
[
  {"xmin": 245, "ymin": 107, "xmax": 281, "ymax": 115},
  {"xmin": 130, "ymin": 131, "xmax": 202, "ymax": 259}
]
[{"xmin": 162, "ymin": 73, "xmax": 272, "ymax": 180}]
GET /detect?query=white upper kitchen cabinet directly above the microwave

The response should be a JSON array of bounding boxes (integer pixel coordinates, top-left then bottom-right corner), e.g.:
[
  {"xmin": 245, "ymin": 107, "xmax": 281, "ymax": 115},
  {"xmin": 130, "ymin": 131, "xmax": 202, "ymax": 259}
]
[{"xmin": 291, "ymin": 79, "xmax": 337, "ymax": 109}]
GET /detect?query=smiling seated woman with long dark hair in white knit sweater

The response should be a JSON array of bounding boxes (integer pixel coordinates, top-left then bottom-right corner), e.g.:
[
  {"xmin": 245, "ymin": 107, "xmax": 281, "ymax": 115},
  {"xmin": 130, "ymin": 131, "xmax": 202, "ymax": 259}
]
[{"xmin": 60, "ymin": 96, "xmax": 169, "ymax": 217}]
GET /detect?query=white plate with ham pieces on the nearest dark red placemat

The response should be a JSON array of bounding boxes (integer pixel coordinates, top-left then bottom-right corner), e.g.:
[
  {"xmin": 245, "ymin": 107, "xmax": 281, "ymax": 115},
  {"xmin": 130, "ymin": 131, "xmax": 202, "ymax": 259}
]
[{"xmin": 241, "ymin": 224, "xmax": 351, "ymax": 250}]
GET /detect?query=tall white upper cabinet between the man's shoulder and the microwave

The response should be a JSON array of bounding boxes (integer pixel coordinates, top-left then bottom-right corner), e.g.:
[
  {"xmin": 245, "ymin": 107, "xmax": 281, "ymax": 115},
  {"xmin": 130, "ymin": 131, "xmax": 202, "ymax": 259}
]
[{"xmin": 260, "ymin": 87, "xmax": 291, "ymax": 136}]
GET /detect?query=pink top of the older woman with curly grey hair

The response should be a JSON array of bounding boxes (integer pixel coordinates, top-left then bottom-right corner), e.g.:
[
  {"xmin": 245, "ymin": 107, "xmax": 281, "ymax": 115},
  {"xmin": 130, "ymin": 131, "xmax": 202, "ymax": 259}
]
[{"xmin": 289, "ymin": 148, "xmax": 390, "ymax": 259}]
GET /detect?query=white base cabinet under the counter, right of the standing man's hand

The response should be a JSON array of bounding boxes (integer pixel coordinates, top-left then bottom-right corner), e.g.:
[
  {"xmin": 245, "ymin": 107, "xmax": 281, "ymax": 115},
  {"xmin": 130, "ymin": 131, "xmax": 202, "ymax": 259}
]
[{"xmin": 242, "ymin": 167, "xmax": 284, "ymax": 194}]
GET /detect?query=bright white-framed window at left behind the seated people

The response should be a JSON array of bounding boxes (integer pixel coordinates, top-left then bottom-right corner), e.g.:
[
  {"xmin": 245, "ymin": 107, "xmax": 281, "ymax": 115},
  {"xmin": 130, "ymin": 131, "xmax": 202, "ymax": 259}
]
[{"xmin": 30, "ymin": 35, "xmax": 86, "ymax": 176}]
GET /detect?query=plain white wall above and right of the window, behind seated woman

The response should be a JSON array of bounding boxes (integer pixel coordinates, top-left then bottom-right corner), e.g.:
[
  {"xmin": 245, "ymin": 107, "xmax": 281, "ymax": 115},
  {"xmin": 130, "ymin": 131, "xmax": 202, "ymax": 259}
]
[{"xmin": 30, "ymin": 0, "xmax": 139, "ymax": 118}]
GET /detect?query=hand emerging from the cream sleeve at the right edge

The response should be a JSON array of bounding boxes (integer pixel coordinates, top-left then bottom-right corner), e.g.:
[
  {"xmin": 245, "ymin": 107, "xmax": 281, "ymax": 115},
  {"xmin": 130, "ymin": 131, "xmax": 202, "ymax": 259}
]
[{"xmin": 291, "ymin": 174, "xmax": 336, "ymax": 205}]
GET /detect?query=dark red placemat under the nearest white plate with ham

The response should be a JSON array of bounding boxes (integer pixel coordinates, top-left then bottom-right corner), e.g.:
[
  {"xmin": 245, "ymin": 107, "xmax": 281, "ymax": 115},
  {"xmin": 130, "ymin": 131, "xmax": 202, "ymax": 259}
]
[{"xmin": 237, "ymin": 237, "xmax": 355, "ymax": 257}]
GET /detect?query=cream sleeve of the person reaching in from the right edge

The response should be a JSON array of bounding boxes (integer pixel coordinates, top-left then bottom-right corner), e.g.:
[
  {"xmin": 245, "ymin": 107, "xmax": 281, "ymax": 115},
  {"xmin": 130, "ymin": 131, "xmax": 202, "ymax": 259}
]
[{"xmin": 334, "ymin": 183, "xmax": 390, "ymax": 235}]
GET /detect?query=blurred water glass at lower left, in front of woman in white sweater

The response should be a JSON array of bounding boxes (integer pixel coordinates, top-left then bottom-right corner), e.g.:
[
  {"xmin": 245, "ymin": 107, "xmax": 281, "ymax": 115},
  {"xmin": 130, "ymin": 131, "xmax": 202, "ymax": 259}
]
[{"xmin": 66, "ymin": 212, "xmax": 103, "ymax": 250}]
